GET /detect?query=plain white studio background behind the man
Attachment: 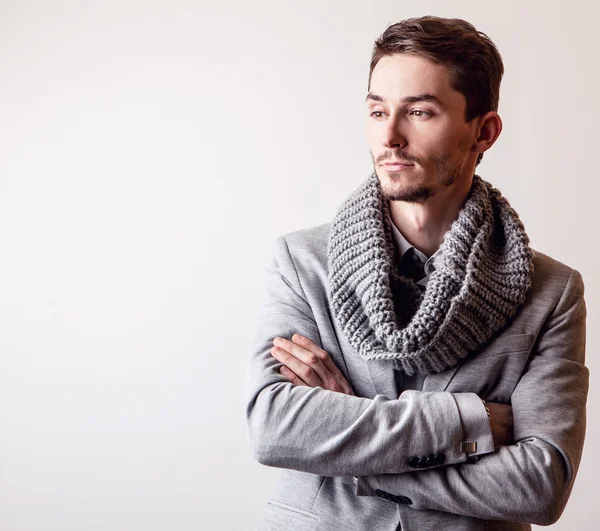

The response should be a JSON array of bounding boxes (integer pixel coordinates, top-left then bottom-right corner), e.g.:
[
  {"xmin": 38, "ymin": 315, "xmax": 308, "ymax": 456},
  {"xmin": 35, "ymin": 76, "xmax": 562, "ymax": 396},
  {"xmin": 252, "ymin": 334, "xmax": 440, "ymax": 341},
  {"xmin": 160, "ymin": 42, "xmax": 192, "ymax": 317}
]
[{"xmin": 0, "ymin": 0, "xmax": 600, "ymax": 531}]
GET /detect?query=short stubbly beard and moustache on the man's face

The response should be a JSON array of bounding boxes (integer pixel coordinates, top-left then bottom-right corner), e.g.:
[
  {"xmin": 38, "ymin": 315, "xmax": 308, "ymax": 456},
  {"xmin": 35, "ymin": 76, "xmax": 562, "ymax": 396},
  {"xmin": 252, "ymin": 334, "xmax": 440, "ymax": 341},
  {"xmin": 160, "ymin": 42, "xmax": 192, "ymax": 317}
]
[{"xmin": 371, "ymin": 135, "xmax": 472, "ymax": 204}]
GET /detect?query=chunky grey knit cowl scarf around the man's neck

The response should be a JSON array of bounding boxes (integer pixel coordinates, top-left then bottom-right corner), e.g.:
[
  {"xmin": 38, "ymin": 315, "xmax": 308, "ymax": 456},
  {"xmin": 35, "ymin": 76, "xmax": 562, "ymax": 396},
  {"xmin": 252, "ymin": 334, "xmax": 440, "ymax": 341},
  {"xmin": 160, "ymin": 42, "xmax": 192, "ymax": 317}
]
[{"xmin": 328, "ymin": 172, "xmax": 534, "ymax": 374}]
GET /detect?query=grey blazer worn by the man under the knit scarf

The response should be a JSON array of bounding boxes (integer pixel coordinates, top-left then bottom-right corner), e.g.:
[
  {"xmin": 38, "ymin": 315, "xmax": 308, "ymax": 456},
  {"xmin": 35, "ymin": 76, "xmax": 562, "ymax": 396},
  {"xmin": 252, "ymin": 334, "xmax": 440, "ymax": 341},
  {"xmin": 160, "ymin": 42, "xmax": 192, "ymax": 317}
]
[{"xmin": 246, "ymin": 223, "xmax": 589, "ymax": 531}]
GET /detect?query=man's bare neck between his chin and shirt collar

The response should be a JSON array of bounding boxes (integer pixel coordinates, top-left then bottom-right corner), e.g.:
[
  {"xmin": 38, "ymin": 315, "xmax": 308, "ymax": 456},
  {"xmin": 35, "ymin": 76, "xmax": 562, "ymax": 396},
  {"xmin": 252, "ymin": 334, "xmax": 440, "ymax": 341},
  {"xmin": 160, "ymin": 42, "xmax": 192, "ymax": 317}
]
[{"xmin": 390, "ymin": 176, "xmax": 473, "ymax": 257}]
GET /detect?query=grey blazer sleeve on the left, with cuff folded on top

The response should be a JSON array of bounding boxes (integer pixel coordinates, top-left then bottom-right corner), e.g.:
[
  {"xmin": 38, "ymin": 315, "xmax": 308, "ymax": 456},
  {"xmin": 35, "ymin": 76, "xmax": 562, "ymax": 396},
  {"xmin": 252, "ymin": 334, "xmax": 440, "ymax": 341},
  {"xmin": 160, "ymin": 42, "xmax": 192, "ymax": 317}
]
[{"xmin": 245, "ymin": 236, "xmax": 478, "ymax": 476}]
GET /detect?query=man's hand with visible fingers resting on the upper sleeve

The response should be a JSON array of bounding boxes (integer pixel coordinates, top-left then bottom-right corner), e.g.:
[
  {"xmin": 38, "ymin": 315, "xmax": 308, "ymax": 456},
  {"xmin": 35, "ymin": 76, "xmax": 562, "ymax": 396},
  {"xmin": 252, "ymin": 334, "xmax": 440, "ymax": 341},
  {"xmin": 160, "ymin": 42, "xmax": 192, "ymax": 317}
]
[{"xmin": 271, "ymin": 334, "xmax": 354, "ymax": 395}]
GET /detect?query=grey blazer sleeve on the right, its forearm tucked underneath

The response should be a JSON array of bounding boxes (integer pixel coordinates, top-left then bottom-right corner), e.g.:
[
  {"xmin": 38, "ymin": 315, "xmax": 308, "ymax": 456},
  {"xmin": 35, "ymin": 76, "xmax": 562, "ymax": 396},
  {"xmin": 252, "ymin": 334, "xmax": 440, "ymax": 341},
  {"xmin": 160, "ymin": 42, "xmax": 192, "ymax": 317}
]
[{"xmin": 356, "ymin": 270, "xmax": 589, "ymax": 525}]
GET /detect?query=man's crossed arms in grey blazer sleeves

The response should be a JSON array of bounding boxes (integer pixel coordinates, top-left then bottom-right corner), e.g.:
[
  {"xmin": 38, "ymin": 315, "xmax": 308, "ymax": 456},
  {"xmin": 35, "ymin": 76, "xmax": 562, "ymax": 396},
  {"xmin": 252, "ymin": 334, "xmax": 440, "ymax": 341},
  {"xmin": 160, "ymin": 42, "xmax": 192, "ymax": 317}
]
[{"xmin": 246, "ymin": 238, "xmax": 588, "ymax": 525}]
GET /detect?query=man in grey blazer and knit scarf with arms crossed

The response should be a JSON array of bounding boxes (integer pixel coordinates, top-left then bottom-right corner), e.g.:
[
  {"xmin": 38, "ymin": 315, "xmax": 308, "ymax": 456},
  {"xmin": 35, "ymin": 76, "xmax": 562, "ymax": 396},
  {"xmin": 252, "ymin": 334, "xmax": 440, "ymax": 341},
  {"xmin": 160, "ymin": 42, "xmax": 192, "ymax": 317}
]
[{"xmin": 246, "ymin": 16, "xmax": 588, "ymax": 531}]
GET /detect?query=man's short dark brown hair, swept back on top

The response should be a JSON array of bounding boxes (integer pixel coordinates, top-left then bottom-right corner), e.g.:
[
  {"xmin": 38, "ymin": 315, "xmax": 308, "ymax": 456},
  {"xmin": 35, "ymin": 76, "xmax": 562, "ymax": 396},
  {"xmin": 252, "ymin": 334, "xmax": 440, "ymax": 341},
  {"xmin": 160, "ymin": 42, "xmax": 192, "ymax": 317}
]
[{"xmin": 367, "ymin": 15, "xmax": 504, "ymax": 166}]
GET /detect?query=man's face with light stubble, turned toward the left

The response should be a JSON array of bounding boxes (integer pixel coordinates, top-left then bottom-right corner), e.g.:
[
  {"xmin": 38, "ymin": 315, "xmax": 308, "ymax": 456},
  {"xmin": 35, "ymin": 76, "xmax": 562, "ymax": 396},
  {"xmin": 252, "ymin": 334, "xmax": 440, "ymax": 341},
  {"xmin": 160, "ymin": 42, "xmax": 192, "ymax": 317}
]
[{"xmin": 366, "ymin": 54, "xmax": 478, "ymax": 203}]
